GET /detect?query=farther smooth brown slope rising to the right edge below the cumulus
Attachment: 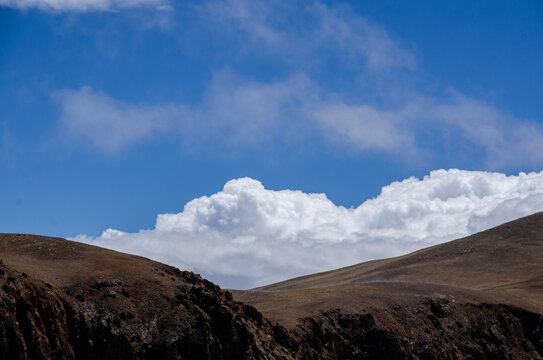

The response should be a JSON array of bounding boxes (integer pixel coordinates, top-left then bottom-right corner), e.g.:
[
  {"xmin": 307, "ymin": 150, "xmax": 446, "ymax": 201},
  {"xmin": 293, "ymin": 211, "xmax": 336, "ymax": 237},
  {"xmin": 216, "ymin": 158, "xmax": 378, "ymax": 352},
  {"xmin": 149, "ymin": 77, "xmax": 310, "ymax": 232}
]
[{"xmin": 256, "ymin": 213, "xmax": 543, "ymax": 296}]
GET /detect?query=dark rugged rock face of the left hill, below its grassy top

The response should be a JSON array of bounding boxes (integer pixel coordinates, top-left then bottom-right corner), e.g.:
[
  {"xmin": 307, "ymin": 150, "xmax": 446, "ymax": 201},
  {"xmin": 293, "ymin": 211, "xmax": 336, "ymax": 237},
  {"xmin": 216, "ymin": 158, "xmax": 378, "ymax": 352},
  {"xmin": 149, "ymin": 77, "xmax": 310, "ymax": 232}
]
[{"xmin": 0, "ymin": 266, "xmax": 289, "ymax": 359}]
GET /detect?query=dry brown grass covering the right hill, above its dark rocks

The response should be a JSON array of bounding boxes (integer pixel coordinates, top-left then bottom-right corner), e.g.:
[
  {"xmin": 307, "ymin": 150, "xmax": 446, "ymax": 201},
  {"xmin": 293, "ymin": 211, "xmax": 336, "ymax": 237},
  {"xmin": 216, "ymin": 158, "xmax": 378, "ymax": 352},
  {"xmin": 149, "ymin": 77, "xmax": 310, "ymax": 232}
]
[{"xmin": 234, "ymin": 213, "xmax": 543, "ymax": 327}]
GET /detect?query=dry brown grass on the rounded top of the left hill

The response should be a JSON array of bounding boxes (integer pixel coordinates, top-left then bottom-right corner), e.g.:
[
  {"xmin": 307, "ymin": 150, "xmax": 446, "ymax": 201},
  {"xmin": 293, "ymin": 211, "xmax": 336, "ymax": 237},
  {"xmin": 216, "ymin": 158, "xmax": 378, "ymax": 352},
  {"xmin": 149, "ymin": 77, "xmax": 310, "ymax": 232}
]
[{"xmin": 0, "ymin": 234, "xmax": 180, "ymax": 308}]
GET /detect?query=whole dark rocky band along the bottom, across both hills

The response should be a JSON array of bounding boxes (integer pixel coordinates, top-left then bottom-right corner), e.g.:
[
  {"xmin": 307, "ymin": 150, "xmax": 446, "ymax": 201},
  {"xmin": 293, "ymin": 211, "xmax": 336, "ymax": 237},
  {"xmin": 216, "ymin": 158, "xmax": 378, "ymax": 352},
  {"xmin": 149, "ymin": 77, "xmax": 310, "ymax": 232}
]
[{"xmin": 0, "ymin": 265, "xmax": 543, "ymax": 360}]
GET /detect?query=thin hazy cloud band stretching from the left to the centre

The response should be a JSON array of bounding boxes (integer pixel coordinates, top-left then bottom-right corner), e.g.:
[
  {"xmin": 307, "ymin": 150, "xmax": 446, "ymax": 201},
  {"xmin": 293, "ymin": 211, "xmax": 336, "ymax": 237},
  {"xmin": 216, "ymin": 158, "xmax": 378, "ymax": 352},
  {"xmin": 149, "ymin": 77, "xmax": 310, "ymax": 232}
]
[{"xmin": 53, "ymin": 75, "xmax": 317, "ymax": 153}]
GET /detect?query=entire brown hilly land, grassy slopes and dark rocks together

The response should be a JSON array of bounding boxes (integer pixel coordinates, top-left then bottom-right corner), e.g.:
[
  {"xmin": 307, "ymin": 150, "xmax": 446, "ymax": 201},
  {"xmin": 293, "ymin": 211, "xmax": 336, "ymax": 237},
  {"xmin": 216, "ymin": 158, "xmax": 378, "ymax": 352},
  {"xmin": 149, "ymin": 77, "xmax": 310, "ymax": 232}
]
[{"xmin": 0, "ymin": 213, "xmax": 543, "ymax": 359}]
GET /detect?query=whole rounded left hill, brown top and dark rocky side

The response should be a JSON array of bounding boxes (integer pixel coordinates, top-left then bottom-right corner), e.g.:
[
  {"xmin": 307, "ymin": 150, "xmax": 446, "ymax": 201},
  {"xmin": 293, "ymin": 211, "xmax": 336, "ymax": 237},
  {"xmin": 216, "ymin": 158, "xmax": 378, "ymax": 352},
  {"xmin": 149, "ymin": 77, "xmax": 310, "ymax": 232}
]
[{"xmin": 0, "ymin": 234, "xmax": 294, "ymax": 359}]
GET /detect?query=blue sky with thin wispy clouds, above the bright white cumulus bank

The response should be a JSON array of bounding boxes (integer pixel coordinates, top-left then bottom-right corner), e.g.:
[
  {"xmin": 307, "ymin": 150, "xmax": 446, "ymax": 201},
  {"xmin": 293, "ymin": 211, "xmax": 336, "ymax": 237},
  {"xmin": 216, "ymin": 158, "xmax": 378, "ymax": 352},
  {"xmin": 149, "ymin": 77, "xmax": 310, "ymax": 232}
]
[{"xmin": 0, "ymin": 0, "xmax": 543, "ymax": 286}]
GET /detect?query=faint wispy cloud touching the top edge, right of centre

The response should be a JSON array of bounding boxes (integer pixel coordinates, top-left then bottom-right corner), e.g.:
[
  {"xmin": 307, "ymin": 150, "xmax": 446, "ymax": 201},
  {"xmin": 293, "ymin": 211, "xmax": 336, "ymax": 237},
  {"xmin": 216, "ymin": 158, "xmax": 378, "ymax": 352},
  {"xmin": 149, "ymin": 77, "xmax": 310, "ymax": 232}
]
[{"xmin": 201, "ymin": 0, "xmax": 415, "ymax": 71}]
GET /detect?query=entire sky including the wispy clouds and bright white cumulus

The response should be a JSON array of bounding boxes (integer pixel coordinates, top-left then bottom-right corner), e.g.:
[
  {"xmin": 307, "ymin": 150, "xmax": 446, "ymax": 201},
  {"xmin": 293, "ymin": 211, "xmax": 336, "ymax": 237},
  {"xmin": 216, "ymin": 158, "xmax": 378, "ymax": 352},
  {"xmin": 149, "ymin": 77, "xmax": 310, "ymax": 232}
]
[{"xmin": 0, "ymin": 0, "xmax": 543, "ymax": 288}]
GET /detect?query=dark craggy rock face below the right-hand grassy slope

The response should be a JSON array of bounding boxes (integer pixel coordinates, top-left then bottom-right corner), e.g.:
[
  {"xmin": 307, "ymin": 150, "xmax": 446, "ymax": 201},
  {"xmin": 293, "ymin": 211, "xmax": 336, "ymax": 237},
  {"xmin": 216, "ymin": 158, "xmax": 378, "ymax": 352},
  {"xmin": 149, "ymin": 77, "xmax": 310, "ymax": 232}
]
[{"xmin": 296, "ymin": 301, "xmax": 543, "ymax": 360}]
